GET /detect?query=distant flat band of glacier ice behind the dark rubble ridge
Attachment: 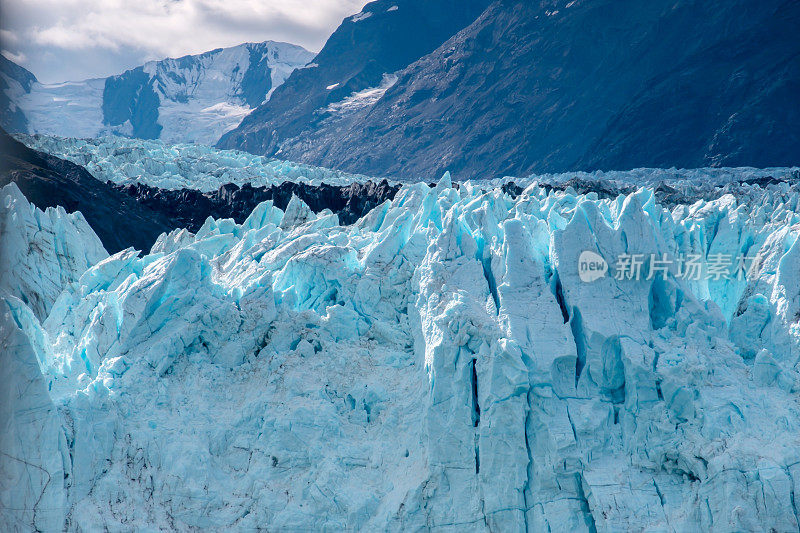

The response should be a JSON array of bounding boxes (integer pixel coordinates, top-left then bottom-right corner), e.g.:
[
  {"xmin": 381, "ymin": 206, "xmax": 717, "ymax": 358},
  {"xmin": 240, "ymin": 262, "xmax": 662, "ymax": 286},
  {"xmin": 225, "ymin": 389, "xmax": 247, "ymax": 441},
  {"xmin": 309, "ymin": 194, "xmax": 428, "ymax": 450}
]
[{"xmin": 15, "ymin": 132, "xmax": 800, "ymax": 195}]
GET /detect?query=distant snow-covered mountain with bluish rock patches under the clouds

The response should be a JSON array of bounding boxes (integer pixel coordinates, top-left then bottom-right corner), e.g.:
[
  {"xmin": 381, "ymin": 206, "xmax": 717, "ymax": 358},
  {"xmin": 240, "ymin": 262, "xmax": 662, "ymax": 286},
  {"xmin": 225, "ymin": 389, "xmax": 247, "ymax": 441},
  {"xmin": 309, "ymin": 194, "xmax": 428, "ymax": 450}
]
[{"xmin": 12, "ymin": 41, "xmax": 313, "ymax": 144}]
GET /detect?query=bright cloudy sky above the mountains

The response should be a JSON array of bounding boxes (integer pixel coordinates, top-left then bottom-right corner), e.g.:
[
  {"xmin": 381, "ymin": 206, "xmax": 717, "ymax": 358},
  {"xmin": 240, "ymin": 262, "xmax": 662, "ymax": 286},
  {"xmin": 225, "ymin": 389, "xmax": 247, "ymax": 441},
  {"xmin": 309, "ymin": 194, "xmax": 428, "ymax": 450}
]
[{"xmin": 0, "ymin": 0, "xmax": 367, "ymax": 83}]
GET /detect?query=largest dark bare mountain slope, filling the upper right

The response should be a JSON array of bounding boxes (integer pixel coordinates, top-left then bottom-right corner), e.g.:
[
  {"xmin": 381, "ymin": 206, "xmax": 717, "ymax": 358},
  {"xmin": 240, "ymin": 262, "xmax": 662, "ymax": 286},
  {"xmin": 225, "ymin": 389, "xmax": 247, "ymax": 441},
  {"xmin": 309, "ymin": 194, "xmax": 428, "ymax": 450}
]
[{"xmin": 220, "ymin": 0, "xmax": 800, "ymax": 179}]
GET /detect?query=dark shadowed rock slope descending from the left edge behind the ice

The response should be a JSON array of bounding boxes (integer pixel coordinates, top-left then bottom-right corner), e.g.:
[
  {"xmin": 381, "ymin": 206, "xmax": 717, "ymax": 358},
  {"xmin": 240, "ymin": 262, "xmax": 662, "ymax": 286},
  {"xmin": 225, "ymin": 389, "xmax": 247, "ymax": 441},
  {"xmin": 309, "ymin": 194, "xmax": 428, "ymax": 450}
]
[{"xmin": 0, "ymin": 131, "xmax": 176, "ymax": 253}]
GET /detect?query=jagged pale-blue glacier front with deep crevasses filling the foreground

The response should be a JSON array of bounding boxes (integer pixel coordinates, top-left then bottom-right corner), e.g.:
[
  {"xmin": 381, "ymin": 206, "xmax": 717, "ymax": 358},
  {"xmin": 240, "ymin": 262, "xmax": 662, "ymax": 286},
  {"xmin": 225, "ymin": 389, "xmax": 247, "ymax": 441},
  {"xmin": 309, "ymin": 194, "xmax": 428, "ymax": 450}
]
[{"xmin": 0, "ymin": 172, "xmax": 800, "ymax": 531}]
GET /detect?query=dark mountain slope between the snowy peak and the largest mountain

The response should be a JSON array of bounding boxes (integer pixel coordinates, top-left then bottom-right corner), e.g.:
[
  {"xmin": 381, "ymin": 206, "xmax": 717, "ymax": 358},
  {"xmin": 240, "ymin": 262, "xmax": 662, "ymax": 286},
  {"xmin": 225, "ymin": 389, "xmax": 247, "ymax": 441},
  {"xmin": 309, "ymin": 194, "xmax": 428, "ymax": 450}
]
[{"xmin": 218, "ymin": 0, "xmax": 490, "ymax": 156}]
